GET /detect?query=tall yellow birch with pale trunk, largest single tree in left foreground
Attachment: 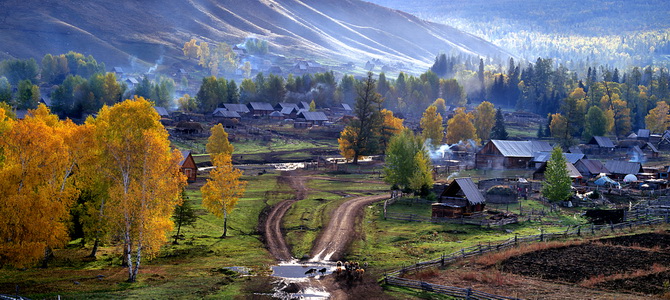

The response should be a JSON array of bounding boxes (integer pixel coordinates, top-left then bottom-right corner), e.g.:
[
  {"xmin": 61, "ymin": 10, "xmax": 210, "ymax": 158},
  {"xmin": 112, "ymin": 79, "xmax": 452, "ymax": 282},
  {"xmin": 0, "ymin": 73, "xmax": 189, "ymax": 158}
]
[{"xmin": 89, "ymin": 97, "xmax": 186, "ymax": 282}]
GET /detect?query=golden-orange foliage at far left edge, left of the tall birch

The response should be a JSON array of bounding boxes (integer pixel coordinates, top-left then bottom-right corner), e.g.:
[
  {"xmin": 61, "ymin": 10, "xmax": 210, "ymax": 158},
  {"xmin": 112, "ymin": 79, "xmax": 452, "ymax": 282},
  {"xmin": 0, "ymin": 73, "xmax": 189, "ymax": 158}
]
[{"xmin": 0, "ymin": 105, "xmax": 78, "ymax": 267}]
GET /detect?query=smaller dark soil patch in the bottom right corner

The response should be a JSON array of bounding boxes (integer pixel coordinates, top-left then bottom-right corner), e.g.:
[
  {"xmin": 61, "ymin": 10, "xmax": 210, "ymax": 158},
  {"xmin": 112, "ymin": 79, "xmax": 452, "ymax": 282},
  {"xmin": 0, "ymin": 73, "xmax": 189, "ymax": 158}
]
[{"xmin": 596, "ymin": 271, "xmax": 670, "ymax": 295}]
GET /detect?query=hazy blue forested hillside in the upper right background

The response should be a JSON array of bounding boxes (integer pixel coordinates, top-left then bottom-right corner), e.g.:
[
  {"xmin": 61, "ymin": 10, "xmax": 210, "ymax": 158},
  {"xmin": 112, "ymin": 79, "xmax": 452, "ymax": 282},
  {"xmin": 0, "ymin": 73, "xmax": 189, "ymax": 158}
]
[{"xmin": 371, "ymin": 0, "xmax": 670, "ymax": 67}]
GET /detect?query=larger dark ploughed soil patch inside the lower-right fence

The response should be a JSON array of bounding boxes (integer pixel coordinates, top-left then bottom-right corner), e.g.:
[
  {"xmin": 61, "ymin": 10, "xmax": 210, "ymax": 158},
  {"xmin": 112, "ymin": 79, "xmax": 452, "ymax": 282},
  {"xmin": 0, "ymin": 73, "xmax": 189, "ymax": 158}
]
[{"xmin": 501, "ymin": 243, "xmax": 670, "ymax": 283}]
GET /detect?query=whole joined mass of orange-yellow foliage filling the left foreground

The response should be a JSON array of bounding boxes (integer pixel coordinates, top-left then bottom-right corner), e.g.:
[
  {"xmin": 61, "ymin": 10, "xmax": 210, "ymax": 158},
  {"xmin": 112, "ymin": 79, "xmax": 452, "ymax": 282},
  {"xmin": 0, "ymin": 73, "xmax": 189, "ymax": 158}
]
[{"xmin": 0, "ymin": 98, "xmax": 185, "ymax": 280}]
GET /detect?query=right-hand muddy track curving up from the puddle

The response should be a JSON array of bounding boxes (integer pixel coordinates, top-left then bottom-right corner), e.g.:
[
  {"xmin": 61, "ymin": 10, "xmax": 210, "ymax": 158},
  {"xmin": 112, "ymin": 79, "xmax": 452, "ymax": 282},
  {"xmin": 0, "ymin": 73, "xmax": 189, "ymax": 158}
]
[{"xmin": 311, "ymin": 194, "xmax": 389, "ymax": 260}]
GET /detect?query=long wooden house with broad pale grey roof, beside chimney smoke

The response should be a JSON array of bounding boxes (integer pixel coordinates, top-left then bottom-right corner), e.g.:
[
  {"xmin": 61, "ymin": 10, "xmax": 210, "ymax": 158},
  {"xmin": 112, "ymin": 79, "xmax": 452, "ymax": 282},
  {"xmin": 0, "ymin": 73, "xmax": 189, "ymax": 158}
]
[{"xmin": 475, "ymin": 140, "xmax": 552, "ymax": 169}]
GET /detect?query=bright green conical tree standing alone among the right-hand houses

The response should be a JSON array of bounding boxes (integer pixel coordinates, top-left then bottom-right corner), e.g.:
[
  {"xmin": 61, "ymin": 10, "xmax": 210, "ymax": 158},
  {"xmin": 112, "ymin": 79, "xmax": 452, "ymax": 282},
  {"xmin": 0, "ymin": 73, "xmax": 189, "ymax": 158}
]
[{"xmin": 542, "ymin": 147, "xmax": 572, "ymax": 202}]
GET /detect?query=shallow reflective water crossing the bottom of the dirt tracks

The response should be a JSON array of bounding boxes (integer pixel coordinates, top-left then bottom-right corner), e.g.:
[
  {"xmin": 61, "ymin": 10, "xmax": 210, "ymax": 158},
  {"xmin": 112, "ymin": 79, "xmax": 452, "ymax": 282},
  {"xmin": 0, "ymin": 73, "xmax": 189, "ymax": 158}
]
[{"xmin": 272, "ymin": 261, "xmax": 335, "ymax": 300}]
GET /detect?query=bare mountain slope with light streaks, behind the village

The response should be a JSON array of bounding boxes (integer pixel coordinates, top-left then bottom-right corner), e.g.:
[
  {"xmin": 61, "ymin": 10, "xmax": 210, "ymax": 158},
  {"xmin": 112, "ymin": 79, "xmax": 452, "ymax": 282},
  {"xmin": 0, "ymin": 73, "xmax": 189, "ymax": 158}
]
[{"xmin": 0, "ymin": 0, "xmax": 507, "ymax": 68}]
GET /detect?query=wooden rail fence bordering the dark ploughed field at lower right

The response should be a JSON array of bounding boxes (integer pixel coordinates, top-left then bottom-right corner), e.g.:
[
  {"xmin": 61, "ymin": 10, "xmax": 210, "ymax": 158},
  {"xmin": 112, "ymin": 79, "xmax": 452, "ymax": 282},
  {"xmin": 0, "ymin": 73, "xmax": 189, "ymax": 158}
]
[{"xmin": 383, "ymin": 215, "xmax": 670, "ymax": 300}]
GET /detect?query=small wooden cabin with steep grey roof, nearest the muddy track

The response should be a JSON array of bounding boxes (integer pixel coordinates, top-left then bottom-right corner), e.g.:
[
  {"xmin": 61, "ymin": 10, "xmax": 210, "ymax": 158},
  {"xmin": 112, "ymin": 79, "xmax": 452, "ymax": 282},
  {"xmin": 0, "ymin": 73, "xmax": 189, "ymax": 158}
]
[{"xmin": 432, "ymin": 178, "xmax": 486, "ymax": 218}]
